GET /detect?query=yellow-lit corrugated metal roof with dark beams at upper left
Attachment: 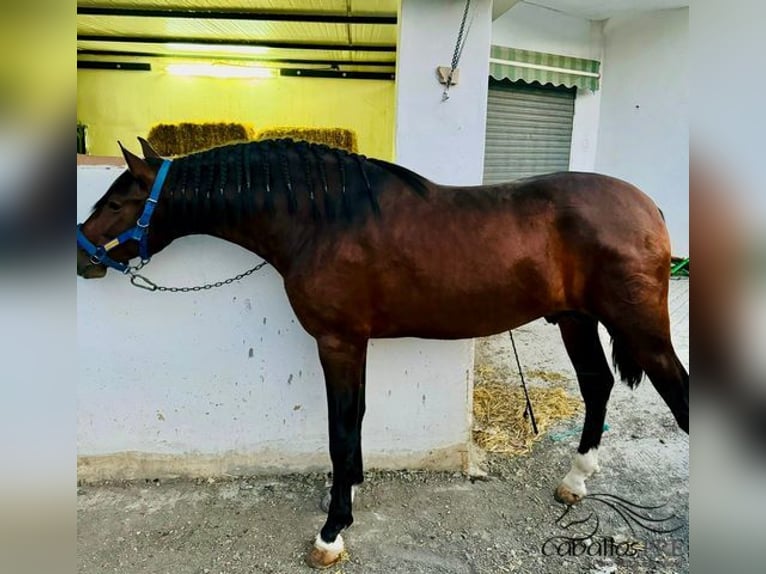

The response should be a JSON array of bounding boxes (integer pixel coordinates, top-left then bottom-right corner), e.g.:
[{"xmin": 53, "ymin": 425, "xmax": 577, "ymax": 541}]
[{"xmin": 77, "ymin": 0, "xmax": 397, "ymax": 73}]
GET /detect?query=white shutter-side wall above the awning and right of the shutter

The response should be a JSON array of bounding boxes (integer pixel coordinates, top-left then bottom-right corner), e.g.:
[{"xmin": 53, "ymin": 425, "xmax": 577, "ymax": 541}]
[{"xmin": 492, "ymin": 3, "xmax": 603, "ymax": 171}]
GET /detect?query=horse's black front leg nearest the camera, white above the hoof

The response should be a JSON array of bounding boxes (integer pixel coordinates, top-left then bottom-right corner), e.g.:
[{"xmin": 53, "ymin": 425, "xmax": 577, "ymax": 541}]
[{"xmin": 307, "ymin": 336, "xmax": 367, "ymax": 568}]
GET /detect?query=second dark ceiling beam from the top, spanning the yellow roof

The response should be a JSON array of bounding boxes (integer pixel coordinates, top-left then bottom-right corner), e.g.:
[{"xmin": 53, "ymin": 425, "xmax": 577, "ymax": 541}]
[{"xmin": 77, "ymin": 34, "xmax": 396, "ymax": 52}]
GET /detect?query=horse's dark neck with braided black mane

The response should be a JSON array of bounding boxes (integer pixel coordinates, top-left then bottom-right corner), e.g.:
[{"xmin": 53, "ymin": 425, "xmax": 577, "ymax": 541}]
[{"xmin": 162, "ymin": 141, "xmax": 392, "ymax": 274}]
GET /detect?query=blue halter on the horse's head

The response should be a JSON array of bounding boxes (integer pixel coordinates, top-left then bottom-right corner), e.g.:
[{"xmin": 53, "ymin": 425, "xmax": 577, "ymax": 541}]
[{"xmin": 77, "ymin": 159, "xmax": 172, "ymax": 273}]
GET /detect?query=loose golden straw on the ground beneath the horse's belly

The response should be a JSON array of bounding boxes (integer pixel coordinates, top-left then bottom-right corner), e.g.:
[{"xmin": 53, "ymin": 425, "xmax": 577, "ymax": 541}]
[{"xmin": 473, "ymin": 366, "xmax": 580, "ymax": 455}]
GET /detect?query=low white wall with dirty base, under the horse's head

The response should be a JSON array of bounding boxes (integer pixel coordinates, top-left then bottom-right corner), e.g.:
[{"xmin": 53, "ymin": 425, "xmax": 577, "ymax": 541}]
[{"xmin": 77, "ymin": 166, "xmax": 473, "ymax": 479}]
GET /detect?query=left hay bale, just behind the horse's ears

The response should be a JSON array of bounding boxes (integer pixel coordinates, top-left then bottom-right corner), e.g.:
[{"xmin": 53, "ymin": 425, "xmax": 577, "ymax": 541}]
[{"xmin": 146, "ymin": 122, "xmax": 253, "ymax": 156}]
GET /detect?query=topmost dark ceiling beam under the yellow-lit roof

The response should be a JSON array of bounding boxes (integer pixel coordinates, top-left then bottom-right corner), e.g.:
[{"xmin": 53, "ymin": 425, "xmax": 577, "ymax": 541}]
[{"xmin": 77, "ymin": 6, "xmax": 397, "ymax": 25}]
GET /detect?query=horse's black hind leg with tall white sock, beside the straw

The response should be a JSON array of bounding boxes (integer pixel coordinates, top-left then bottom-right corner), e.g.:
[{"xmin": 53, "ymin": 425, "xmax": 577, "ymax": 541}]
[{"xmin": 555, "ymin": 315, "xmax": 614, "ymax": 505}]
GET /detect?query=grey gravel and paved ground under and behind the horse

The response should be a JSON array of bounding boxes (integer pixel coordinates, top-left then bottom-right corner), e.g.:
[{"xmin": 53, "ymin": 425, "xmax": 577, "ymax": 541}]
[{"xmin": 78, "ymin": 280, "xmax": 689, "ymax": 574}]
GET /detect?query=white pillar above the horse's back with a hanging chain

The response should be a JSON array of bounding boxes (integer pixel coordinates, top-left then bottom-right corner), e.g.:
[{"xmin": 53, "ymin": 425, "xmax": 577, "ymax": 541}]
[{"xmin": 395, "ymin": 0, "xmax": 492, "ymax": 185}]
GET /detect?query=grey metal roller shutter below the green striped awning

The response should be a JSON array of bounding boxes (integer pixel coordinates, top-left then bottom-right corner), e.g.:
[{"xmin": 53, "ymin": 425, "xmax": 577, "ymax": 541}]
[{"xmin": 484, "ymin": 80, "xmax": 575, "ymax": 184}]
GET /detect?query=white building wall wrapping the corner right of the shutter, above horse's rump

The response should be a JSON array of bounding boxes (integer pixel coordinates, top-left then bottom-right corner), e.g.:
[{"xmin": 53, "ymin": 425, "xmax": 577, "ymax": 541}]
[{"xmin": 492, "ymin": 3, "xmax": 689, "ymax": 255}]
